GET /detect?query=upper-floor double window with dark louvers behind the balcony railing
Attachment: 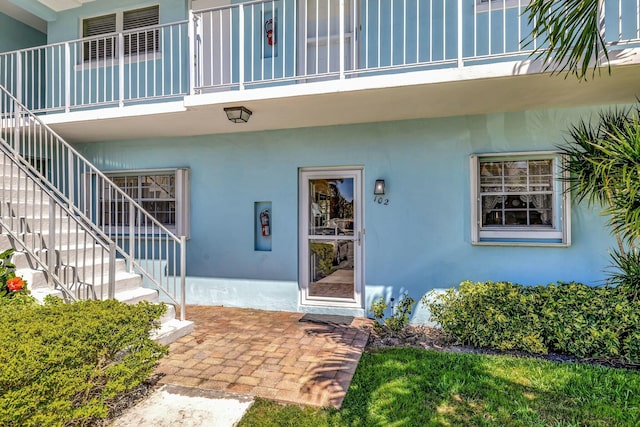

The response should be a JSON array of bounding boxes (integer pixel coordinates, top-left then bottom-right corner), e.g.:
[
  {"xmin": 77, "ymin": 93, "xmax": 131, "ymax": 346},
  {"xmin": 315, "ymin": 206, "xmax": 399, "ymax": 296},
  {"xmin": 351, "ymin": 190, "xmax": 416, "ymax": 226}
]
[{"xmin": 82, "ymin": 6, "xmax": 160, "ymax": 61}]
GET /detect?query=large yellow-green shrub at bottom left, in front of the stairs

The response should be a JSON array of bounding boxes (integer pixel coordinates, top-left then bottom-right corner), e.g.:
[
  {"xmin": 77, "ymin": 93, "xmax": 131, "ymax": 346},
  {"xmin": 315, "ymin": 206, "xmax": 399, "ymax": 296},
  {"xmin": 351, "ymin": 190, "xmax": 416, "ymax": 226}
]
[{"xmin": 0, "ymin": 300, "xmax": 167, "ymax": 426}]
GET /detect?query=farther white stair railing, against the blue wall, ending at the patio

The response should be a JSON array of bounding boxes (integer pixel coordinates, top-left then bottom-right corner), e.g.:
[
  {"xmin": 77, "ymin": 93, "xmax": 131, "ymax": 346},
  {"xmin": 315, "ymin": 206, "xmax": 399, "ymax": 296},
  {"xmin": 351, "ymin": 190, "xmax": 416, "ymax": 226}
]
[{"xmin": 0, "ymin": 85, "xmax": 186, "ymax": 320}]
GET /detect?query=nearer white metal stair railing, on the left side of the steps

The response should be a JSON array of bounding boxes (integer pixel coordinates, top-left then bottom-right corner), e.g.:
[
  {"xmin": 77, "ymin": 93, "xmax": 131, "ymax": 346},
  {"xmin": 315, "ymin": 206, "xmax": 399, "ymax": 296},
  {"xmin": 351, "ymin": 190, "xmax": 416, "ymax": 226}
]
[{"xmin": 0, "ymin": 145, "xmax": 116, "ymax": 301}]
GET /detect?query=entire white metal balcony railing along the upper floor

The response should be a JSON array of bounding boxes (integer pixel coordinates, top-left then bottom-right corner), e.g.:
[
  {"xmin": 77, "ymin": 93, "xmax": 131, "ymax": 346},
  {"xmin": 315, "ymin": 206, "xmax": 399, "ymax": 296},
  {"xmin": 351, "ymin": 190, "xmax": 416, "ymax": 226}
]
[{"xmin": 0, "ymin": 0, "xmax": 640, "ymax": 112}]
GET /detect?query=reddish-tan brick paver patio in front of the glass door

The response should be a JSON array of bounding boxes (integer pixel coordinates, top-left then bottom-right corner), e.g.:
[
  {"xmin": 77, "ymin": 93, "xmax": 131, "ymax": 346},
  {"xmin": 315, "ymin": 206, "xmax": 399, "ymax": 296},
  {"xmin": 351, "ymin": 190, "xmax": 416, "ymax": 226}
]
[{"xmin": 157, "ymin": 306, "xmax": 369, "ymax": 408}]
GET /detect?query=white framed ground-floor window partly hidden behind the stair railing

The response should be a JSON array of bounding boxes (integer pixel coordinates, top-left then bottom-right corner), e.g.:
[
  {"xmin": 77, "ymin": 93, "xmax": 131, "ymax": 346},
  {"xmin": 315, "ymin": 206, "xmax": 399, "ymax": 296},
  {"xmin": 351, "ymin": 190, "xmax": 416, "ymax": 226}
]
[{"xmin": 100, "ymin": 168, "xmax": 190, "ymax": 237}]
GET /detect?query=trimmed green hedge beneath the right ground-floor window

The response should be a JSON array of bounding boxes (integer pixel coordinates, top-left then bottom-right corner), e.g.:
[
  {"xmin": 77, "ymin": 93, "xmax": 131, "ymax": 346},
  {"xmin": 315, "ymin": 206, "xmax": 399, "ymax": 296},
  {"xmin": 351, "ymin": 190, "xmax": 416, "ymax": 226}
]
[{"xmin": 422, "ymin": 281, "xmax": 640, "ymax": 363}]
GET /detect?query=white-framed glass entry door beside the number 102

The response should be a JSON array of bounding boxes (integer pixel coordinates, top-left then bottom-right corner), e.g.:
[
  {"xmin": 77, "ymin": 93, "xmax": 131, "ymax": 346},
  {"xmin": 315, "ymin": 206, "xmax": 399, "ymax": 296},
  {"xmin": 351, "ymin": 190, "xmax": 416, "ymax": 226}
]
[{"xmin": 300, "ymin": 169, "xmax": 363, "ymax": 308}]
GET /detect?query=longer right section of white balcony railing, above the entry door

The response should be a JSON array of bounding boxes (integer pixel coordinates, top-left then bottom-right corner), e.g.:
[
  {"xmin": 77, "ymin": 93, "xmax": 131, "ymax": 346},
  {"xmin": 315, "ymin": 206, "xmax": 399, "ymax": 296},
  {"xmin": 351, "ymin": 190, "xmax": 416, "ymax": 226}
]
[{"xmin": 194, "ymin": 0, "xmax": 640, "ymax": 93}]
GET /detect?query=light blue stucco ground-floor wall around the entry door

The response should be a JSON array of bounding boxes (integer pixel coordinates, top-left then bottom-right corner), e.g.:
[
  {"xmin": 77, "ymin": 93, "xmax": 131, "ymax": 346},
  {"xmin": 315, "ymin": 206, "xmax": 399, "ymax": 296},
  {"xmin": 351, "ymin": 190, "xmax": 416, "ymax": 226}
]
[{"xmin": 77, "ymin": 109, "xmax": 612, "ymax": 318}]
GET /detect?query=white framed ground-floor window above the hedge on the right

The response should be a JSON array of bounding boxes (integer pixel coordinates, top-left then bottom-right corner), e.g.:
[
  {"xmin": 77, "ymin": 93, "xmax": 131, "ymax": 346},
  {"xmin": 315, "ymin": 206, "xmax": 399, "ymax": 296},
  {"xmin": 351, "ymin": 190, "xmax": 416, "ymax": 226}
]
[{"xmin": 470, "ymin": 152, "xmax": 571, "ymax": 246}]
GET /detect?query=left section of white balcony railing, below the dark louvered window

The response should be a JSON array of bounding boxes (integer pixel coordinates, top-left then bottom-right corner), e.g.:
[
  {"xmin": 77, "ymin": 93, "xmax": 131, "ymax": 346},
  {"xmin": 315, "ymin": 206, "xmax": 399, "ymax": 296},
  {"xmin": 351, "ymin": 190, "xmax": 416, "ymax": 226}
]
[{"xmin": 0, "ymin": 21, "xmax": 189, "ymax": 112}]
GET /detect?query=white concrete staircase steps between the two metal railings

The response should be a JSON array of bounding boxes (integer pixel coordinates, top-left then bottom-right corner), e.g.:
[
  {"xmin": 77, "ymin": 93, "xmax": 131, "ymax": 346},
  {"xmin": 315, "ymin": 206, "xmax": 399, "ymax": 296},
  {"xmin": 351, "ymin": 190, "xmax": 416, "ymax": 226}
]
[{"xmin": 0, "ymin": 153, "xmax": 193, "ymax": 344}]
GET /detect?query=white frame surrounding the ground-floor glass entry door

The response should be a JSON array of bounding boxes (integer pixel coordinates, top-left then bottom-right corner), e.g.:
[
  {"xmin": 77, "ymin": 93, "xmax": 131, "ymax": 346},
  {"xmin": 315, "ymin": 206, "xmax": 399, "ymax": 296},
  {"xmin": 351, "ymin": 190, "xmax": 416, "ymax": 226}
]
[{"xmin": 298, "ymin": 166, "xmax": 365, "ymax": 309}]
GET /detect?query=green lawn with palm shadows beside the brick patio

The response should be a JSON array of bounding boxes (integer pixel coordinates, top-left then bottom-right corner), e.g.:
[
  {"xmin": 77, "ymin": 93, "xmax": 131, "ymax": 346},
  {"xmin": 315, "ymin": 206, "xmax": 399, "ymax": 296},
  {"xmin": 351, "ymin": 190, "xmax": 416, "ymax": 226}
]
[{"xmin": 240, "ymin": 349, "xmax": 640, "ymax": 427}]
